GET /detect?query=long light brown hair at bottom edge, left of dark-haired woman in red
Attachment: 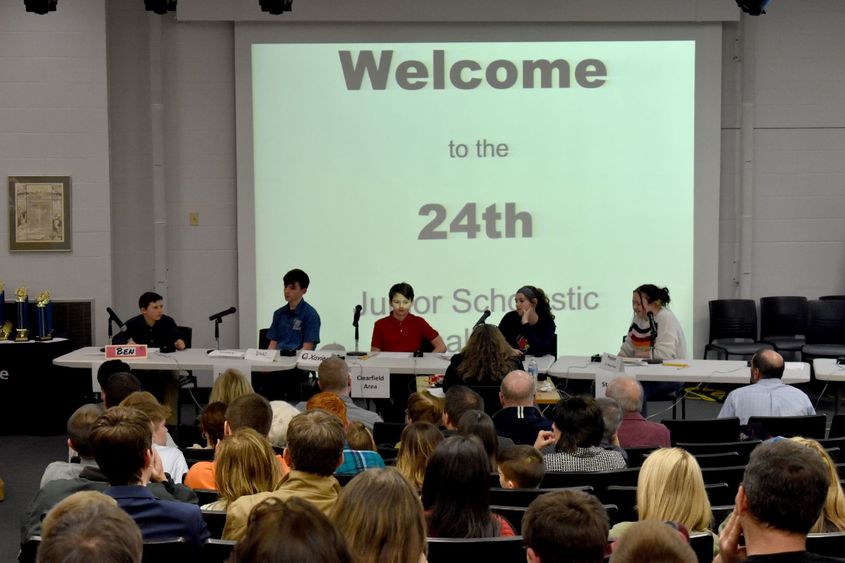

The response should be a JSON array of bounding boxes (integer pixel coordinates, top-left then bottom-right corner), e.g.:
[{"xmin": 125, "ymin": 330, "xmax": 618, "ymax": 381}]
[{"xmin": 331, "ymin": 467, "xmax": 426, "ymax": 563}]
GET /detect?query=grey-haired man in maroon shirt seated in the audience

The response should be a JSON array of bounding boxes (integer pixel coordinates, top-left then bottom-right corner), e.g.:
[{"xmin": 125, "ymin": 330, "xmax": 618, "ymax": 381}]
[{"xmin": 605, "ymin": 376, "xmax": 672, "ymax": 448}]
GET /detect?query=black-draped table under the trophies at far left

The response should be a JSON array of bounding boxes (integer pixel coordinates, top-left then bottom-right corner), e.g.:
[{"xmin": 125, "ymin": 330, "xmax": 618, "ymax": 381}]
[{"xmin": 0, "ymin": 338, "xmax": 90, "ymax": 435}]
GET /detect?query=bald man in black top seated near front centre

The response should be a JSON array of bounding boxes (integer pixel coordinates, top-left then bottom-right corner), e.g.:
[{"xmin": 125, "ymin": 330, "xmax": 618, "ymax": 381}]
[{"xmin": 493, "ymin": 370, "xmax": 552, "ymax": 445}]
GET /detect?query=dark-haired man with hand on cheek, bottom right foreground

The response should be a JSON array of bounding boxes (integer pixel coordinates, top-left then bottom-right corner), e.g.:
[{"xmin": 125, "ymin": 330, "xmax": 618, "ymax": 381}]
[{"xmin": 714, "ymin": 440, "xmax": 840, "ymax": 563}]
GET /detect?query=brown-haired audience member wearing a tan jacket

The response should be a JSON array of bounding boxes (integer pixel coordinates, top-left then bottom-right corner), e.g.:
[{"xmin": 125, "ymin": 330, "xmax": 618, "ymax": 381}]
[{"xmin": 223, "ymin": 409, "xmax": 346, "ymax": 540}]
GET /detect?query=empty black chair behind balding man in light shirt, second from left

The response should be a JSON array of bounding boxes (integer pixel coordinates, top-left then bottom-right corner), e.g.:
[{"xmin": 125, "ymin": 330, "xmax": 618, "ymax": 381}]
[{"xmin": 760, "ymin": 295, "xmax": 808, "ymax": 359}]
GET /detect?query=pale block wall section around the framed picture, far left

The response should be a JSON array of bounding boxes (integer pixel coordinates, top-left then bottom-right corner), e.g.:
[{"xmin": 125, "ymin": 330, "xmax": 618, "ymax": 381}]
[{"xmin": 0, "ymin": 0, "xmax": 112, "ymax": 337}]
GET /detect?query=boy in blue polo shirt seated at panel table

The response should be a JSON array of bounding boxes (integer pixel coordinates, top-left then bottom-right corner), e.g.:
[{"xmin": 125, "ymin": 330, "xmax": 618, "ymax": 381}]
[{"xmin": 267, "ymin": 268, "xmax": 320, "ymax": 350}]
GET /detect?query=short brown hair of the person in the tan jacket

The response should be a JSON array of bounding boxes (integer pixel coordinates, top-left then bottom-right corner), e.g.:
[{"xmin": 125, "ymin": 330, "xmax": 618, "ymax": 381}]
[{"xmin": 287, "ymin": 409, "xmax": 346, "ymax": 477}]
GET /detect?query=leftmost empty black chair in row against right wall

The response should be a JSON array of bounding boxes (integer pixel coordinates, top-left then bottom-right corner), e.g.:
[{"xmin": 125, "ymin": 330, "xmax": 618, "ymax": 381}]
[{"xmin": 704, "ymin": 299, "xmax": 772, "ymax": 360}]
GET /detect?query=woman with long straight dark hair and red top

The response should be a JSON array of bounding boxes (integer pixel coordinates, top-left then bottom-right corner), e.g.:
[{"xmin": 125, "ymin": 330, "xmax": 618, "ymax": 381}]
[{"xmin": 422, "ymin": 436, "xmax": 514, "ymax": 538}]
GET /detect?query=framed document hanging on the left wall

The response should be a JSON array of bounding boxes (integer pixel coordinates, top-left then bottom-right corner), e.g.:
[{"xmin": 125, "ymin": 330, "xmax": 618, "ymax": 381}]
[{"xmin": 9, "ymin": 176, "xmax": 71, "ymax": 251}]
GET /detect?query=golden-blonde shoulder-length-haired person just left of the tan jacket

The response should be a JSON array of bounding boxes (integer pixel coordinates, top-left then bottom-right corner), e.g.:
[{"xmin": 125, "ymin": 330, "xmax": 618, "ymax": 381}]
[{"xmin": 202, "ymin": 428, "xmax": 282, "ymax": 510}]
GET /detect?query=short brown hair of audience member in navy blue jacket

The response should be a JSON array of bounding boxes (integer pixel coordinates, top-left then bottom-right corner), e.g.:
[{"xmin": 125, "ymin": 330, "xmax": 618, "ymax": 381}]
[{"xmin": 90, "ymin": 407, "xmax": 153, "ymax": 485}]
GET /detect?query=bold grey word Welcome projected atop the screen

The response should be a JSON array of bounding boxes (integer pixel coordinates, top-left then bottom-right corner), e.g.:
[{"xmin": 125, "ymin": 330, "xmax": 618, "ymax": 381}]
[{"xmin": 338, "ymin": 50, "xmax": 607, "ymax": 90}]
